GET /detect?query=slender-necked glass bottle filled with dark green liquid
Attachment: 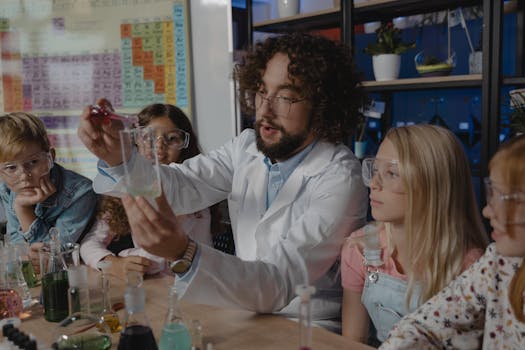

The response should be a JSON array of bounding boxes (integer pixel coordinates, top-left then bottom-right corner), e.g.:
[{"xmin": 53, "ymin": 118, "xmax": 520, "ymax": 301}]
[{"xmin": 40, "ymin": 228, "xmax": 69, "ymax": 322}]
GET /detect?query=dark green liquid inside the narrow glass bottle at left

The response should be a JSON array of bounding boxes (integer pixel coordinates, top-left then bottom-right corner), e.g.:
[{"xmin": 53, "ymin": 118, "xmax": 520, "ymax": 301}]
[{"xmin": 42, "ymin": 271, "xmax": 69, "ymax": 322}]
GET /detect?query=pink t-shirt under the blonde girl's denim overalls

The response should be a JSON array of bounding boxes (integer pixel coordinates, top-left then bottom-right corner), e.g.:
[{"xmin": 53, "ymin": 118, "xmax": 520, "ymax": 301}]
[{"xmin": 341, "ymin": 226, "xmax": 483, "ymax": 293}]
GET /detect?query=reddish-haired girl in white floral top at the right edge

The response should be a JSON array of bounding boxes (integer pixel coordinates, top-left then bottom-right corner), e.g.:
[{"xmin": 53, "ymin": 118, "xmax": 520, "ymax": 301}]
[{"xmin": 381, "ymin": 135, "xmax": 525, "ymax": 350}]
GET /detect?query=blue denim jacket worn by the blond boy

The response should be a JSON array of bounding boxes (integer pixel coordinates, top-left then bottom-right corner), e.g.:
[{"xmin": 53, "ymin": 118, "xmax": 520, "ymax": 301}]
[{"xmin": 0, "ymin": 163, "xmax": 97, "ymax": 243}]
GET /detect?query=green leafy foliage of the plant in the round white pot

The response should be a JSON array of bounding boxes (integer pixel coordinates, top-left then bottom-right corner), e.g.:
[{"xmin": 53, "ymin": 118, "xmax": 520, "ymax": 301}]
[{"xmin": 364, "ymin": 22, "xmax": 416, "ymax": 56}]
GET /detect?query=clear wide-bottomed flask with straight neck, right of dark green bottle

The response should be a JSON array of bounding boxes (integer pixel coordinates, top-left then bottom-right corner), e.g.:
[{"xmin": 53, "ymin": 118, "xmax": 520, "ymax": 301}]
[{"xmin": 51, "ymin": 265, "xmax": 111, "ymax": 350}]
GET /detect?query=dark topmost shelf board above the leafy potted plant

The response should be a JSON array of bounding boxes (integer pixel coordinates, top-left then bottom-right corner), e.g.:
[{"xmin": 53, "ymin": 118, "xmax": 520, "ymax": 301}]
[{"xmin": 352, "ymin": 0, "xmax": 483, "ymax": 23}]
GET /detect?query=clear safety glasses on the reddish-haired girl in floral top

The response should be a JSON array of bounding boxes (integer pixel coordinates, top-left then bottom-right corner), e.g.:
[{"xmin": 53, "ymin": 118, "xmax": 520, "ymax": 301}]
[{"xmin": 484, "ymin": 177, "xmax": 525, "ymax": 225}]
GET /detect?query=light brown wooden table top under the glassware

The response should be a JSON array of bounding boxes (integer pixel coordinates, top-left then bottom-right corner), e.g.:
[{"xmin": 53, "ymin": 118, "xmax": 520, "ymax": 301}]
[{"xmin": 20, "ymin": 271, "xmax": 372, "ymax": 350}]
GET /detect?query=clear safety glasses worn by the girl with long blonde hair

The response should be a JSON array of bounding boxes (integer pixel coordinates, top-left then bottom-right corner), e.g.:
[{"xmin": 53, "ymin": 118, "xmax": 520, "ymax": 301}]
[{"xmin": 362, "ymin": 157, "xmax": 405, "ymax": 193}]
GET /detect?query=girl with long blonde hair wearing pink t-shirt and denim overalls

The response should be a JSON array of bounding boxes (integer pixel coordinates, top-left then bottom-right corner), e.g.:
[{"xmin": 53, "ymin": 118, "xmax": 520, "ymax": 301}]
[{"xmin": 341, "ymin": 125, "xmax": 486, "ymax": 345}]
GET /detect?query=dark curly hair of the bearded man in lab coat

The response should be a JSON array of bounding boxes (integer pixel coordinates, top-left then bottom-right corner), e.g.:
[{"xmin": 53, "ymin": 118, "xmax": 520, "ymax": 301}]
[{"xmin": 234, "ymin": 33, "xmax": 366, "ymax": 143}]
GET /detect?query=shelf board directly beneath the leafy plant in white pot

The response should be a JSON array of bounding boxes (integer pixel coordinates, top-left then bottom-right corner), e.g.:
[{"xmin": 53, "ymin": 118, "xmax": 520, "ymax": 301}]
[{"xmin": 363, "ymin": 74, "xmax": 482, "ymax": 92}]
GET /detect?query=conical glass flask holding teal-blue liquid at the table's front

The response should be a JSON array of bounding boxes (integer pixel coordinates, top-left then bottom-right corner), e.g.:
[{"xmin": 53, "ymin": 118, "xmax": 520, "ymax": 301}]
[{"xmin": 159, "ymin": 285, "xmax": 192, "ymax": 350}]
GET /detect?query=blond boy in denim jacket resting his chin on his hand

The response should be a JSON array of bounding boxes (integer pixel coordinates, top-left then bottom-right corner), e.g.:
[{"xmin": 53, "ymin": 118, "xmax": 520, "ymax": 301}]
[{"xmin": 0, "ymin": 112, "xmax": 96, "ymax": 243}]
